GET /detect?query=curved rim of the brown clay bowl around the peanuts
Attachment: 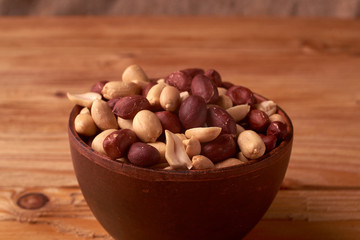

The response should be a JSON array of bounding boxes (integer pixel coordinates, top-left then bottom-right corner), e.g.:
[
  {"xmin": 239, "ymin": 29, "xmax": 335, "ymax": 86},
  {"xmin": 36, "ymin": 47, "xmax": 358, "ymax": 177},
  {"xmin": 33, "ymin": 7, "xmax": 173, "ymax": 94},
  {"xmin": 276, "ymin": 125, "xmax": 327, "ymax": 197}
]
[{"xmin": 68, "ymin": 93, "xmax": 294, "ymax": 181}]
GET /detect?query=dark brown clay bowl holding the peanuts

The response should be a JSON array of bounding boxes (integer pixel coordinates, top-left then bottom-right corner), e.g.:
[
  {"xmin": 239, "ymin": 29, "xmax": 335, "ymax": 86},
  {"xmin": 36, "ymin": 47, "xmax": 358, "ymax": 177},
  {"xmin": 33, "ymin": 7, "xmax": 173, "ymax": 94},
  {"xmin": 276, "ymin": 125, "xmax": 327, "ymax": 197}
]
[{"xmin": 68, "ymin": 94, "xmax": 293, "ymax": 240}]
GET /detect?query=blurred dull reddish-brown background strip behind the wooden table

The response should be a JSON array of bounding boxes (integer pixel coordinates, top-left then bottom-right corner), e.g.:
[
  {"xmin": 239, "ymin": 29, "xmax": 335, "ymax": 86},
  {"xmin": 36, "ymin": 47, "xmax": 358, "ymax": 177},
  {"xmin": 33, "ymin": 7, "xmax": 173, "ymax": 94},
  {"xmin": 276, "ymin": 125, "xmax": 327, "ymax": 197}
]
[{"xmin": 0, "ymin": 0, "xmax": 360, "ymax": 18}]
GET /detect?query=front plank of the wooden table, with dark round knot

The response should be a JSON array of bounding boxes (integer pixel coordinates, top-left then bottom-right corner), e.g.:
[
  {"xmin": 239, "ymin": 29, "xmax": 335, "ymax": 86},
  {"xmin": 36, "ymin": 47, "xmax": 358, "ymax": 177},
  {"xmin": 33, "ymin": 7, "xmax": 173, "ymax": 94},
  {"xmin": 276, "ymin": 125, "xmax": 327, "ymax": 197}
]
[{"xmin": 0, "ymin": 187, "xmax": 360, "ymax": 239}]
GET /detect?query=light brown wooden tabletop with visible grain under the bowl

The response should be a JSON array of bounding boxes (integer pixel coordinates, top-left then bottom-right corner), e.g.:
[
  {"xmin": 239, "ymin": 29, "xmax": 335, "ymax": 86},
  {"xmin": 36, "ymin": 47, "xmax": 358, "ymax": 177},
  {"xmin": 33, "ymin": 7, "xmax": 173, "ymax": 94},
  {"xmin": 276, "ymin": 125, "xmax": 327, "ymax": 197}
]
[{"xmin": 0, "ymin": 17, "xmax": 360, "ymax": 240}]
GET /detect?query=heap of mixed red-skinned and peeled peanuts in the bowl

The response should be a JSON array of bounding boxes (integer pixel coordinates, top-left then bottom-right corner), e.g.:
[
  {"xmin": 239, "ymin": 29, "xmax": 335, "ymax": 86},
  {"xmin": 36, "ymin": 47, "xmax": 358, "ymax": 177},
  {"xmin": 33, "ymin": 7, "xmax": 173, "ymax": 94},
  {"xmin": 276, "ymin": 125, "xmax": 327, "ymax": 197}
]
[{"xmin": 67, "ymin": 65, "xmax": 287, "ymax": 170}]
